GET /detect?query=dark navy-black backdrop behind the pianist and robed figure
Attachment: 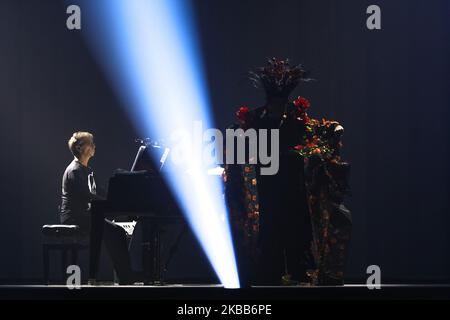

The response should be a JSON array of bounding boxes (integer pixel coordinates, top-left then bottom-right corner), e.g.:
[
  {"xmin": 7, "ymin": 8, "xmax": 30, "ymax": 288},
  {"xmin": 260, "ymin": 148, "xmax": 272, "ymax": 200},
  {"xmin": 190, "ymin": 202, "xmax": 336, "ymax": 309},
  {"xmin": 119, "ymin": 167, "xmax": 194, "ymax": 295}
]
[{"xmin": 0, "ymin": 0, "xmax": 450, "ymax": 283}]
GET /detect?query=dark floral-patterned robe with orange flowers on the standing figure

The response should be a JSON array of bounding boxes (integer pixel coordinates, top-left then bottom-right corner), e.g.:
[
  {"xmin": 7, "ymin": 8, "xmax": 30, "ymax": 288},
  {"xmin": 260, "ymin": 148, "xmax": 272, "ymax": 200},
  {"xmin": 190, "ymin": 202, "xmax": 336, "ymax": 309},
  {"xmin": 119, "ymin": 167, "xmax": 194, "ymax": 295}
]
[{"xmin": 224, "ymin": 100, "xmax": 351, "ymax": 285}]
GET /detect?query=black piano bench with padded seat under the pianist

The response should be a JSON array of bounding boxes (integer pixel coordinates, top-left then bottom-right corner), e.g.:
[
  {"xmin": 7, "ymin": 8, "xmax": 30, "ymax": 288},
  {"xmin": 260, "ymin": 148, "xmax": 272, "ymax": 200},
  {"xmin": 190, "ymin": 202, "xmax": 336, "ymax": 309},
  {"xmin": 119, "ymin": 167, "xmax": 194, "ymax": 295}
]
[{"xmin": 42, "ymin": 224, "xmax": 88, "ymax": 284}]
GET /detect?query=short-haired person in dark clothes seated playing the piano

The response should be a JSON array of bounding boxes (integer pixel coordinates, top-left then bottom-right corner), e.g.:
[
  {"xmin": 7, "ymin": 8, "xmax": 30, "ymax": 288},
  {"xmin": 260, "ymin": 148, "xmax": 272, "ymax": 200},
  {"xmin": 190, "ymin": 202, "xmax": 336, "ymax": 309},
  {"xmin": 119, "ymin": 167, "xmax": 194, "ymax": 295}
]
[{"xmin": 60, "ymin": 132, "xmax": 135, "ymax": 284}]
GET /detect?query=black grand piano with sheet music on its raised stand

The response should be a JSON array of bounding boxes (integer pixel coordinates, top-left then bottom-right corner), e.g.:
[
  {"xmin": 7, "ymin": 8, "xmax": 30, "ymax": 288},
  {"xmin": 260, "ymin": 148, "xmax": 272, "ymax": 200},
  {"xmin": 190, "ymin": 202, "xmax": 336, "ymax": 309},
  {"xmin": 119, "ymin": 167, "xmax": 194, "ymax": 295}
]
[{"xmin": 89, "ymin": 141, "xmax": 184, "ymax": 283}]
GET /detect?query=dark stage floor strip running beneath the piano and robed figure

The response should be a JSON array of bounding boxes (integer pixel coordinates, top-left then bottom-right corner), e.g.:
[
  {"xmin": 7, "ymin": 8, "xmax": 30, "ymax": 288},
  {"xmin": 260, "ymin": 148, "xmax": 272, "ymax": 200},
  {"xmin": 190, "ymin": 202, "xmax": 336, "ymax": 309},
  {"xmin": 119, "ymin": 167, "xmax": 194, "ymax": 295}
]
[{"xmin": 0, "ymin": 284, "xmax": 450, "ymax": 301}]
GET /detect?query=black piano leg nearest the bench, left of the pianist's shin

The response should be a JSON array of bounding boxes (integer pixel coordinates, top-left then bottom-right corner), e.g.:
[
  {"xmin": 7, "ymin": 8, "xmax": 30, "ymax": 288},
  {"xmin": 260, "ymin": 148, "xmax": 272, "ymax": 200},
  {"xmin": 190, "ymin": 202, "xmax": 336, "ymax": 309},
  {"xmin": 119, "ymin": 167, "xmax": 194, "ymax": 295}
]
[{"xmin": 89, "ymin": 208, "xmax": 105, "ymax": 284}]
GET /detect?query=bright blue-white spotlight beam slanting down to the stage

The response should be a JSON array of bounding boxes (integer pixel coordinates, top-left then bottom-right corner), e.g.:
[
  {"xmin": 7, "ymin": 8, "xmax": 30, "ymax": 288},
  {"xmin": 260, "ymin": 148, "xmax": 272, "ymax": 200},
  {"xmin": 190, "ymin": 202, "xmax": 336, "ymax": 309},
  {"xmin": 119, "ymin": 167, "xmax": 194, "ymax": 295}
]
[{"xmin": 83, "ymin": 0, "xmax": 239, "ymax": 288}]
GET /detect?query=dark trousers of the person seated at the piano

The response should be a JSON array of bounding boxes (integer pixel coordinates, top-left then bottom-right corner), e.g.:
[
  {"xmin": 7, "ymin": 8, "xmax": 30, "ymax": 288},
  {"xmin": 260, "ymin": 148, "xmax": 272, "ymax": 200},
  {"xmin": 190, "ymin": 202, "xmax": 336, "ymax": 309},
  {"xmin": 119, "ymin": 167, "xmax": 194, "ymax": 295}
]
[{"xmin": 62, "ymin": 214, "xmax": 132, "ymax": 282}]
